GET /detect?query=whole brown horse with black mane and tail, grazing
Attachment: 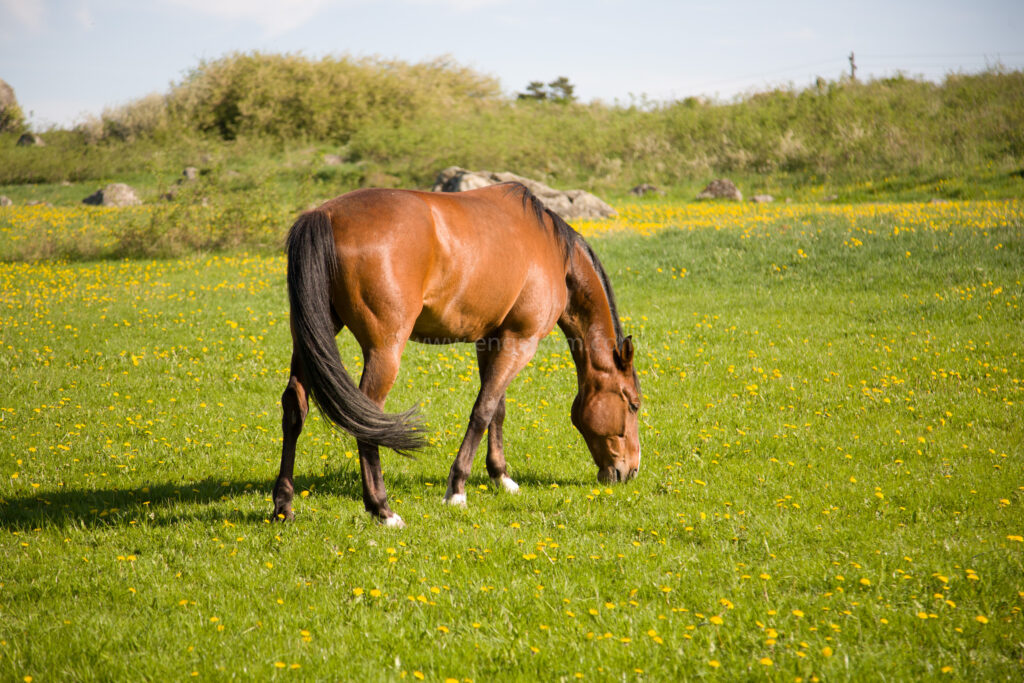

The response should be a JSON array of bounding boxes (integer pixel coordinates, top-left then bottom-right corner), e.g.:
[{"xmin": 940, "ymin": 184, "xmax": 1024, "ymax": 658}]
[{"xmin": 273, "ymin": 183, "xmax": 640, "ymax": 526}]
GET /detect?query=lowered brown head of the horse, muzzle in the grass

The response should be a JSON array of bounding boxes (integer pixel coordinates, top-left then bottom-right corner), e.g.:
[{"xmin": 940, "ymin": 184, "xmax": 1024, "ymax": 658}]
[{"xmin": 572, "ymin": 337, "xmax": 640, "ymax": 482}]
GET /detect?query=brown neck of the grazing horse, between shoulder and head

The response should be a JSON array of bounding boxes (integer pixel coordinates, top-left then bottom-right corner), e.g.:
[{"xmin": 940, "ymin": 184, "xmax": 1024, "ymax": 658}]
[{"xmin": 558, "ymin": 248, "xmax": 615, "ymax": 380}]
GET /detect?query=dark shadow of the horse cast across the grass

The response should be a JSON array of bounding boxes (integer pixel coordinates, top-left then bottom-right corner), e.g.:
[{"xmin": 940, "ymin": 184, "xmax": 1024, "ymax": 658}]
[{"xmin": 0, "ymin": 468, "xmax": 591, "ymax": 531}]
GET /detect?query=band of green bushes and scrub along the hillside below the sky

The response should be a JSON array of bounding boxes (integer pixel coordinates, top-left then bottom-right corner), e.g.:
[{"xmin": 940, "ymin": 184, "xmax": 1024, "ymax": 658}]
[{"xmin": 0, "ymin": 52, "xmax": 1024, "ymax": 200}]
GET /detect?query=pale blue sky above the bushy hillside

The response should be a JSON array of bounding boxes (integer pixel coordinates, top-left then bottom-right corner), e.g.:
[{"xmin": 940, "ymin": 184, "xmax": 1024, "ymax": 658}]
[{"xmin": 0, "ymin": 0, "xmax": 1024, "ymax": 129}]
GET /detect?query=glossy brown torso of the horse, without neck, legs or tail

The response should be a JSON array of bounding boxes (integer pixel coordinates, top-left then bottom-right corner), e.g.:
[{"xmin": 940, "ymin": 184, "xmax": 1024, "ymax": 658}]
[{"xmin": 321, "ymin": 185, "xmax": 564, "ymax": 341}]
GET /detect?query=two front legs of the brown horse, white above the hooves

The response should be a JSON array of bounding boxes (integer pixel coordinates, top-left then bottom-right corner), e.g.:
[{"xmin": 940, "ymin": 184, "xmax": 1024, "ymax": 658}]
[{"xmin": 444, "ymin": 338, "xmax": 539, "ymax": 505}]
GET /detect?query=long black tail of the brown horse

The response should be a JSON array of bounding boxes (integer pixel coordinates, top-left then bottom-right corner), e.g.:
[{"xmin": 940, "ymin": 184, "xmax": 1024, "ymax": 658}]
[{"xmin": 286, "ymin": 211, "xmax": 424, "ymax": 454}]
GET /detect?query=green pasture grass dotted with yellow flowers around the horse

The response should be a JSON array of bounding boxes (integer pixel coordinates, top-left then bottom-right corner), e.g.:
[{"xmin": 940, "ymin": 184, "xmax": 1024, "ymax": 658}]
[{"xmin": 0, "ymin": 202, "xmax": 1024, "ymax": 681}]
